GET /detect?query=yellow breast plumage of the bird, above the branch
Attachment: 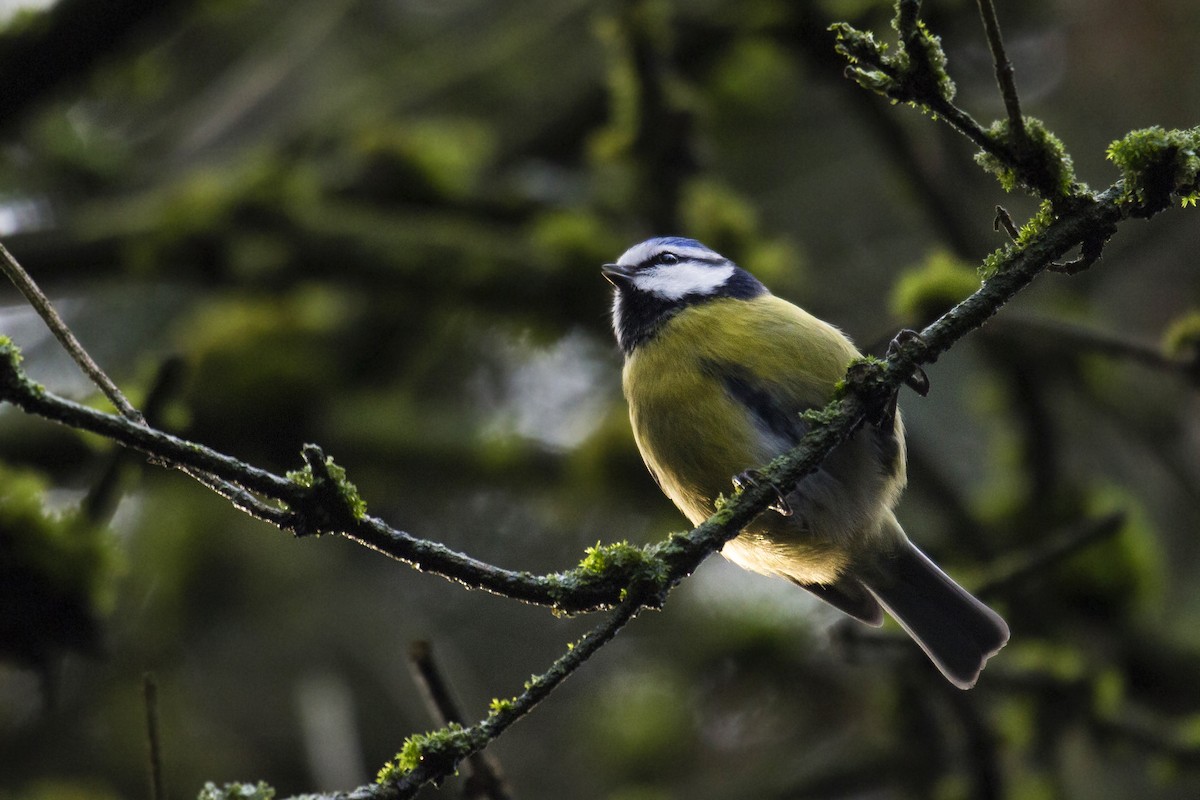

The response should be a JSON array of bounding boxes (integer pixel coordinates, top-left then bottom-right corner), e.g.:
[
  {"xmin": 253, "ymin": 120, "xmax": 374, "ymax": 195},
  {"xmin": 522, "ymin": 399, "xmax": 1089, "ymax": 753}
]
[{"xmin": 624, "ymin": 295, "xmax": 858, "ymax": 523}]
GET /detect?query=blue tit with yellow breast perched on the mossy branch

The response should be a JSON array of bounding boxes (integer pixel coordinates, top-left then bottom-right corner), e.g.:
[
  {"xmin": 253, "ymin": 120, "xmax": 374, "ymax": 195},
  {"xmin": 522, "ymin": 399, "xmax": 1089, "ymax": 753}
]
[{"xmin": 602, "ymin": 236, "xmax": 1008, "ymax": 688}]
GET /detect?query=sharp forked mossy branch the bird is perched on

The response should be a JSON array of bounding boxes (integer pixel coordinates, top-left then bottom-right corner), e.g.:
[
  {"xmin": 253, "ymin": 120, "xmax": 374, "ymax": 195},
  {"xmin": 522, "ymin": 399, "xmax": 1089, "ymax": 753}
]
[{"xmin": 0, "ymin": 169, "xmax": 1161, "ymax": 798}]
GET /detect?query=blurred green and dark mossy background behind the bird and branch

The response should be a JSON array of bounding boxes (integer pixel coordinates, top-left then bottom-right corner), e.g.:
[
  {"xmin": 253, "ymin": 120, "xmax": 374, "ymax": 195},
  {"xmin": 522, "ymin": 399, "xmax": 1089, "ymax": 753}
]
[{"xmin": 0, "ymin": 0, "xmax": 1200, "ymax": 800}]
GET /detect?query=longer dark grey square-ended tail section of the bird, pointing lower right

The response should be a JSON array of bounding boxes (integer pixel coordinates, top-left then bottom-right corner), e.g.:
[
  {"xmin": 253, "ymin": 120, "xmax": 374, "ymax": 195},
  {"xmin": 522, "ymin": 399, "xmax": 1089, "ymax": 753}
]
[{"xmin": 863, "ymin": 539, "xmax": 1008, "ymax": 688}]
